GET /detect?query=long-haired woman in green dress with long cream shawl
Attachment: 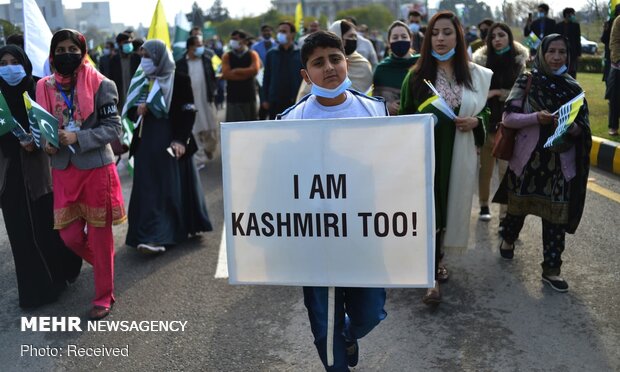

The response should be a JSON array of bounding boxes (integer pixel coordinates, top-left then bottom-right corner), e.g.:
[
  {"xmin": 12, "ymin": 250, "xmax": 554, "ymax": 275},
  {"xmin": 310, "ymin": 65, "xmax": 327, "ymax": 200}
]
[{"xmin": 399, "ymin": 11, "xmax": 493, "ymax": 304}]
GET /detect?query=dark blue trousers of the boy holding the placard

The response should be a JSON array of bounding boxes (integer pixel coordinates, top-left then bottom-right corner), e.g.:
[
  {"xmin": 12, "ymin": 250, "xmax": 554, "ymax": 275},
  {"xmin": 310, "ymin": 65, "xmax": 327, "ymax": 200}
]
[{"xmin": 304, "ymin": 287, "xmax": 387, "ymax": 371}]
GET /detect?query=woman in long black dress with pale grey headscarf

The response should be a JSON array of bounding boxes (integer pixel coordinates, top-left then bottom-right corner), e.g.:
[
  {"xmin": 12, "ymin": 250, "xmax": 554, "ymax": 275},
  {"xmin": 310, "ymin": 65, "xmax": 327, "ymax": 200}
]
[{"xmin": 123, "ymin": 39, "xmax": 212, "ymax": 253}]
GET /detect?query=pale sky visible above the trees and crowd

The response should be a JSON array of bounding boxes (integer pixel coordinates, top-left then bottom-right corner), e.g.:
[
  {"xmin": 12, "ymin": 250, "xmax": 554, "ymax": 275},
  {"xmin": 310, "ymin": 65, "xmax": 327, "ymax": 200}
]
[{"xmin": 0, "ymin": 0, "xmax": 585, "ymax": 27}]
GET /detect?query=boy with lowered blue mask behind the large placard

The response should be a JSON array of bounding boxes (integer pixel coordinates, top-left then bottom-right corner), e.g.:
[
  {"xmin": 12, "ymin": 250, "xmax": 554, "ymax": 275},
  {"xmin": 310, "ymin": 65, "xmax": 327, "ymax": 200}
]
[{"xmin": 277, "ymin": 31, "xmax": 388, "ymax": 371}]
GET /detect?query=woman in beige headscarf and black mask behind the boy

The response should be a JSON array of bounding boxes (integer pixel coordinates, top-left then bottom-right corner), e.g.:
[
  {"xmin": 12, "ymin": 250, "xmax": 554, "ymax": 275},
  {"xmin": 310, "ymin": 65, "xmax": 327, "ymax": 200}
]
[{"xmin": 297, "ymin": 20, "xmax": 372, "ymax": 101}]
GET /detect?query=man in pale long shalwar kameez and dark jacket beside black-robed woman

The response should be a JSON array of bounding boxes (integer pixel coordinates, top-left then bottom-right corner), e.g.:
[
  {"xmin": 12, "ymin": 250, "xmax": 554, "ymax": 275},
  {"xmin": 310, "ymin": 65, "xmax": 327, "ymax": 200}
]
[{"xmin": 176, "ymin": 36, "xmax": 218, "ymax": 169}]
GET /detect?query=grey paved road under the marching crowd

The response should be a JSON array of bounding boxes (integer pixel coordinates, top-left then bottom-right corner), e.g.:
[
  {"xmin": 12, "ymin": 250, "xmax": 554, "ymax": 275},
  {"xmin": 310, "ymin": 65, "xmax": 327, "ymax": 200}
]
[{"xmin": 0, "ymin": 138, "xmax": 620, "ymax": 372}]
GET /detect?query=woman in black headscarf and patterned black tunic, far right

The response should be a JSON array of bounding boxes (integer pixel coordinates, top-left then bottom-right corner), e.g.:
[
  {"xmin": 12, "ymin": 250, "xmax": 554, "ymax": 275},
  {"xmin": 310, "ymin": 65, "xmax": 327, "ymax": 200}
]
[{"xmin": 499, "ymin": 34, "xmax": 592, "ymax": 292}]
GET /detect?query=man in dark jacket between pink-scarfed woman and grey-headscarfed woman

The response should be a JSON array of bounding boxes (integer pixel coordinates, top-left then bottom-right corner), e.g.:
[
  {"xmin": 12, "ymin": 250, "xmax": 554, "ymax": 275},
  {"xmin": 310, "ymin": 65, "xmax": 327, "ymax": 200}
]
[{"xmin": 110, "ymin": 32, "xmax": 140, "ymax": 108}]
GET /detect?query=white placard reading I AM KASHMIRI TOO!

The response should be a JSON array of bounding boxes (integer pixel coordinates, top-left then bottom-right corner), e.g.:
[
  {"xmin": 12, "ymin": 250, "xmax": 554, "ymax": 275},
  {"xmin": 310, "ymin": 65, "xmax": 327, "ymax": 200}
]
[{"xmin": 221, "ymin": 115, "xmax": 435, "ymax": 287}]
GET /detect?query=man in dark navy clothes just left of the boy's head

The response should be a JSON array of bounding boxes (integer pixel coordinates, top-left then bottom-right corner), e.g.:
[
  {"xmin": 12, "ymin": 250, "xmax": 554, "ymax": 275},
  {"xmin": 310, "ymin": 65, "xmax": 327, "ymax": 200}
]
[{"xmin": 263, "ymin": 22, "xmax": 302, "ymax": 119}]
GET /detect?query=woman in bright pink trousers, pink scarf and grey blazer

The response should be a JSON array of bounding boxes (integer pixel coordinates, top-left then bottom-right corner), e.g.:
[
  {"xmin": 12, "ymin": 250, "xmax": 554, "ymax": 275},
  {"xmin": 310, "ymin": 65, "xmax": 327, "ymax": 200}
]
[{"xmin": 37, "ymin": 29, "xmax": 126, "ymax": 319}]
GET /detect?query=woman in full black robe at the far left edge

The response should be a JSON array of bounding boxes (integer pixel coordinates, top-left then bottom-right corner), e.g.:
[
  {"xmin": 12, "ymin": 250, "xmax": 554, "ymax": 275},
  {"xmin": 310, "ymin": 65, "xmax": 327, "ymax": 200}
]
[{"xmin": 0, "ymin": 45, "xmax": 82, "ymax": 307}]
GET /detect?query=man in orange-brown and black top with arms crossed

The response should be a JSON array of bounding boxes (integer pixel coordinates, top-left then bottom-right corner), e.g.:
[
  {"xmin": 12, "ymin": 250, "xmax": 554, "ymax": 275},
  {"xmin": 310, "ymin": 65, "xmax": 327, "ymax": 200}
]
[{"xmin": 222, "ymin": 30, "xmax": 260, "ymax": 121}]
